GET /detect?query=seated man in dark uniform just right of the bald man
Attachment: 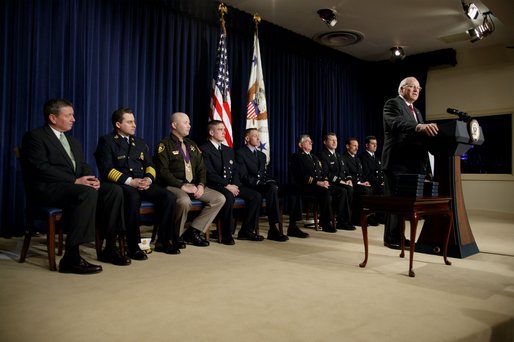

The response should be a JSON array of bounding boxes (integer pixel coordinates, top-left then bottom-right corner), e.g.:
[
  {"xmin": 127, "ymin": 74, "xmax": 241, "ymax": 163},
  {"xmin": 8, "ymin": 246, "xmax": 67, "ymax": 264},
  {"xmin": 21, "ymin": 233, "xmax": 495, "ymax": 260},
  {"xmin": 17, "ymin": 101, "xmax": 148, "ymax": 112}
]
[{"xmin": 200, "ymin": 120, "xmax": 264, "ymax": 245}]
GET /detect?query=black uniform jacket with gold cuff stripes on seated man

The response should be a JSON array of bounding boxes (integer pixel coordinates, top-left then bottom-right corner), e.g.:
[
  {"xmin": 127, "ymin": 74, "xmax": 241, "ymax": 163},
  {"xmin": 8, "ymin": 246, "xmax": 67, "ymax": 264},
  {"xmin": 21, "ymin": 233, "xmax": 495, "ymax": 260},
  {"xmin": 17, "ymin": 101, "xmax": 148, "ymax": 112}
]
[{"xmin": 95, "ymin": 131, "xmax": 156, "ymax": 184}]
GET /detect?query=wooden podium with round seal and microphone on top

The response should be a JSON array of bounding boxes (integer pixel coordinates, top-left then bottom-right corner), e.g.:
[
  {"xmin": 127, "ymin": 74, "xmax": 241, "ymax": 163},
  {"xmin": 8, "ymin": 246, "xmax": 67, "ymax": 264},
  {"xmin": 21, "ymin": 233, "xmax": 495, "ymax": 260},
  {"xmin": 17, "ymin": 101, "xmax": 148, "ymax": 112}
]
[{"xmin": 416, "ymin": 119, "xmax": 484, "ymax": 258}]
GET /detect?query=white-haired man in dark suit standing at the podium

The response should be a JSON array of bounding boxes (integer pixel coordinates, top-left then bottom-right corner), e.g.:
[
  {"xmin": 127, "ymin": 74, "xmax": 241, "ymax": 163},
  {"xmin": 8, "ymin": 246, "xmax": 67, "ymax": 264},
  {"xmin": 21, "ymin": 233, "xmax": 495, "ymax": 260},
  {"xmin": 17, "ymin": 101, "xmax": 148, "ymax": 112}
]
[{"xmin": 382, "ymin": 77, "xmax": 439, "ymax": 249}]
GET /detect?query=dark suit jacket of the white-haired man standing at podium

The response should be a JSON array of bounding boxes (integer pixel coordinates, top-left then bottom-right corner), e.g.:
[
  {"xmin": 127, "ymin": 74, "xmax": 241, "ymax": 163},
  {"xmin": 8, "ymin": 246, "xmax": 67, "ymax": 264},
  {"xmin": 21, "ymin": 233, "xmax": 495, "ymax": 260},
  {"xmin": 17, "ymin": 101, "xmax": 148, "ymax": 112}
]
[{"xmin": 382, "ymin": 96, "xmax": 428, "ymax": 174}]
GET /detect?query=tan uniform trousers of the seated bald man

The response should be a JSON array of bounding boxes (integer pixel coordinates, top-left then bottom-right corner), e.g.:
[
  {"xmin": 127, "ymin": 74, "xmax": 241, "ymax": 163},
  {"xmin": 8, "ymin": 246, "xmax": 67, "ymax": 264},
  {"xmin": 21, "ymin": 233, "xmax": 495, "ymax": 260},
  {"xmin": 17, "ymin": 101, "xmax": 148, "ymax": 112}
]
[{"xmin": 166, "ymin": 186, "xmax": 225, "ymax": 236}]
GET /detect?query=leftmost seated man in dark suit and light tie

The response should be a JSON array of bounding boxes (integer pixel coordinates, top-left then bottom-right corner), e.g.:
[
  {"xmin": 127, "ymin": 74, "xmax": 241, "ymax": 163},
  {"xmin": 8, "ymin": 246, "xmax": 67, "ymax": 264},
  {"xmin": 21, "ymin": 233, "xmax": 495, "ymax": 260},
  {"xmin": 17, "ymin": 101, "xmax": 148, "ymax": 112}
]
[{"xmin": 21, "ymin": 99, "xmax": 125, "ymax": 274}]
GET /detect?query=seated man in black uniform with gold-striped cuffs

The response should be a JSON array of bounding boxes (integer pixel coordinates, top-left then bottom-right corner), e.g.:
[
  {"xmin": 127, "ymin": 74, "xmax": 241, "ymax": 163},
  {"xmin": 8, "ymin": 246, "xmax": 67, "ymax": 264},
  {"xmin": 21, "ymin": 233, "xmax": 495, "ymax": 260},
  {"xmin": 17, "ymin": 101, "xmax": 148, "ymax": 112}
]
[{"xmin": 95, "ymin": 108, "xmax": 181, "ymax": 260}]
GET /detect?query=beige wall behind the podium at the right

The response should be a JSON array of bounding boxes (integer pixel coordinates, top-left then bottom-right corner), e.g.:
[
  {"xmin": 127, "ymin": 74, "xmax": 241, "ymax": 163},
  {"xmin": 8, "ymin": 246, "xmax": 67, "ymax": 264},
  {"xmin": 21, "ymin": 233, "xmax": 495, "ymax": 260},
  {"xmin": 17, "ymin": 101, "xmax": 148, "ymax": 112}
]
[{"xmin": 425, "ymin": 42, "xmax": 514, "ymax": 218}]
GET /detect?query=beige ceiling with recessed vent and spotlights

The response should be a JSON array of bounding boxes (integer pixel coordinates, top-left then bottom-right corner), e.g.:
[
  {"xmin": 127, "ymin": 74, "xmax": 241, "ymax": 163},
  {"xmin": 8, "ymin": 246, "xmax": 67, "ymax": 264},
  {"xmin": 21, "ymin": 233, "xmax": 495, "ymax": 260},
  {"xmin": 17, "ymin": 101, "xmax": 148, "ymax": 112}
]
[{"xmin": 224, "ymin": 0, "xmax": 514, "ymax": 61}]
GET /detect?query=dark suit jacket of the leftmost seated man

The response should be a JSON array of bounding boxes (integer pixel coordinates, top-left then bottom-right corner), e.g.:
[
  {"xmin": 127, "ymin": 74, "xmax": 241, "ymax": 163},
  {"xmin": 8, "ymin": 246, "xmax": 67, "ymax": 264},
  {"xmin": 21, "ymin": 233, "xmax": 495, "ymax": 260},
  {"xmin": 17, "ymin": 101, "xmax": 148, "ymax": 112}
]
[{"xmin": 21, "ymin": 125, "xmax": 94, "ymax": 196}]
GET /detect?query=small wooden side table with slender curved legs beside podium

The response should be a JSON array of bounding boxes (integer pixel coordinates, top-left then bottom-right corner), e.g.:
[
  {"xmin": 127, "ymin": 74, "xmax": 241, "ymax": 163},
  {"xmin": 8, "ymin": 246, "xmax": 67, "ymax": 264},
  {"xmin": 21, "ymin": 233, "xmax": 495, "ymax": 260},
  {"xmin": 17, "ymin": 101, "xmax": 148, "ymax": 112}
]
[{"xmin": 359, "ymin": 196, "xmax": 453, "ymax": 277}]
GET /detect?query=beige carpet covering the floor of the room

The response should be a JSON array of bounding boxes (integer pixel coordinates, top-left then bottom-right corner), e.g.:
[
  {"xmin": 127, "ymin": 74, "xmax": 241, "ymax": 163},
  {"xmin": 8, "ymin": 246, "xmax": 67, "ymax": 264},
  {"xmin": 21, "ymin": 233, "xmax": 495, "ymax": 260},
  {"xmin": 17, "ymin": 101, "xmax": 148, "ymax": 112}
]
[{"xmin": 0, "ymin": 215, "xmax": 514, "ymax": 342}]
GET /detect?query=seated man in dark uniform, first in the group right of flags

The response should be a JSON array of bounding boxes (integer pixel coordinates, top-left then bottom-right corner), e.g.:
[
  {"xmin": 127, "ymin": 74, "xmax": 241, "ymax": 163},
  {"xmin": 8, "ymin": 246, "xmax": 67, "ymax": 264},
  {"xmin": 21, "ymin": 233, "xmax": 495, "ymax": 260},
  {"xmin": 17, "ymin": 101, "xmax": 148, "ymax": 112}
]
[{"xmin": 287, "ymin": 134, "xmax": 341, "ymax": 237}]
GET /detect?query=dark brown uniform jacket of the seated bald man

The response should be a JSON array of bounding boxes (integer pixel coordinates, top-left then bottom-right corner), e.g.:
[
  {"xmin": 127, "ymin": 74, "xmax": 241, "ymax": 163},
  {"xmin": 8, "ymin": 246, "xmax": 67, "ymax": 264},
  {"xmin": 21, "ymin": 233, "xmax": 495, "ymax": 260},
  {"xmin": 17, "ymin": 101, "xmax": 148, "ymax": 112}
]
[{"xmin": 154, "ymin": 134, "xmax": 207, "ymax": 188}]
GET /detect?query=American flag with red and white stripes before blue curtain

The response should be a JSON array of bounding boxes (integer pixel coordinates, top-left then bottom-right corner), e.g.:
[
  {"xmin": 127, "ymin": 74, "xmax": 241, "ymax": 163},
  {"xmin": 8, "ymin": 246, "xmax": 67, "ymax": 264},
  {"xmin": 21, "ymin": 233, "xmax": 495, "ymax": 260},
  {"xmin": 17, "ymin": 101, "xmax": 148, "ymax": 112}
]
[{"xmin": 209, "ymin": 32, "xmax": 233, "ymax": 147}]
